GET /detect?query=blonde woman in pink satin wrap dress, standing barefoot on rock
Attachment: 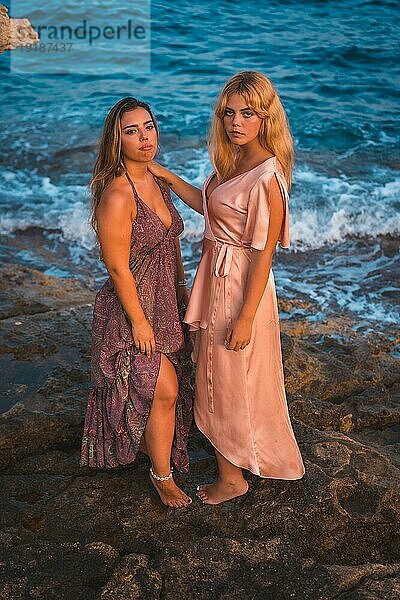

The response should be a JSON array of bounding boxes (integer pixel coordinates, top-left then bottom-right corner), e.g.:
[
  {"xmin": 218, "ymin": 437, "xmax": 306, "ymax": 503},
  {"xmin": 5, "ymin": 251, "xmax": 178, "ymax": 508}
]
[{"xmin": 151, "ymin": 71, "xmax": 304, "ymax": 504}]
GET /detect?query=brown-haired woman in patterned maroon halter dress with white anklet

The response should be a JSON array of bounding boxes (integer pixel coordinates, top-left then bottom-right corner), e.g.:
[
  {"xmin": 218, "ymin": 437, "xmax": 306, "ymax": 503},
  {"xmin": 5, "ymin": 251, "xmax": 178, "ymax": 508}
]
[{"xmin": 81, "ymin": 98, "xmax": 192, "ymax": 508}]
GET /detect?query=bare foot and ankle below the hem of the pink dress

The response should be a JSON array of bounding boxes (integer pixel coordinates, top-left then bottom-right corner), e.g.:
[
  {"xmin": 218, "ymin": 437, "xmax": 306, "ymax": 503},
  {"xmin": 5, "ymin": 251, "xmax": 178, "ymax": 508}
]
[{"xmin": 197, "ymin": 450, "xmax": 249, "ymax": 504}]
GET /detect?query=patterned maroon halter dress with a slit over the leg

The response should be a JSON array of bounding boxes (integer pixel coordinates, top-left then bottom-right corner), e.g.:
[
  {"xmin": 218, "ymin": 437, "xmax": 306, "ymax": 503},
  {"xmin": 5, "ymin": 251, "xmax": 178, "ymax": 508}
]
[{"xmin": 80, "ymin": 176, "xmax": 193, "ymax": 472}]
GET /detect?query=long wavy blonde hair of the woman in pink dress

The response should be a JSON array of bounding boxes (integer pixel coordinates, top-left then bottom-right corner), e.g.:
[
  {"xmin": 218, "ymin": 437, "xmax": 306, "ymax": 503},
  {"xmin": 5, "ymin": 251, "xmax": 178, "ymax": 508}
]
[{"xmin": 208, "ymin": 71, "xmax": 294, "ymax": 190}]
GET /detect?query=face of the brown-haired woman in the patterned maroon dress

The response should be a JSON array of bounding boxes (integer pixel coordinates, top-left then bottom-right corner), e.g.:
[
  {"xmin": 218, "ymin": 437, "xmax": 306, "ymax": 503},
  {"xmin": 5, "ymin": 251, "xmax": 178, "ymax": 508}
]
[{"xmin": 121, "ymin": 107, "xmax": 158, "ymax": 162}]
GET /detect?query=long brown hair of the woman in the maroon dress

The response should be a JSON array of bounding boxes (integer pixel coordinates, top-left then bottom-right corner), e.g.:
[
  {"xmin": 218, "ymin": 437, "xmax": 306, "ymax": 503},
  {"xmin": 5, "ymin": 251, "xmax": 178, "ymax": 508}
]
[{"xmin": 90, "ymin": 97, "xmax": 159, "ymax": 232}]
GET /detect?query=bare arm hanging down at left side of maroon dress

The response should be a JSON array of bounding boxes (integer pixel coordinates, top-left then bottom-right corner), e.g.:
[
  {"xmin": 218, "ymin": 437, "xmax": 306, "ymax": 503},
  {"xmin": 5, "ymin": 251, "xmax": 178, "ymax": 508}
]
[{"xmin": 96, "ymin": 190, "xmax": 155, "ymax": 356}]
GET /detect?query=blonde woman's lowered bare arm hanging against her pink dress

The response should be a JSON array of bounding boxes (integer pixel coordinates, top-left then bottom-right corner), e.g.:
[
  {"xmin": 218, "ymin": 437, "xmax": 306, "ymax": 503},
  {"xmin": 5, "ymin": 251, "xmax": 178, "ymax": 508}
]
[{"xmin": 227, "ymin": 177, "xmax": 284, "ymax": 350}]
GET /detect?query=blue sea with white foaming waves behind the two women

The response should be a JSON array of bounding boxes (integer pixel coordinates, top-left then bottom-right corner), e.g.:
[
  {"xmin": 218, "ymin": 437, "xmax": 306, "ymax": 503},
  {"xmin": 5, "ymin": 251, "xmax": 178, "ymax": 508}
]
[{"xmin": 0, "ymin": 0, "xmax": 400, "ymax": 328}]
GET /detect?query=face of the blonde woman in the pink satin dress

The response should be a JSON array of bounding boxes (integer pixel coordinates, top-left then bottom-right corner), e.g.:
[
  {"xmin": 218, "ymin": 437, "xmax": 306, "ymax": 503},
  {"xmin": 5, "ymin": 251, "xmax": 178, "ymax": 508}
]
[{"xmin": 223, "ymin": 94, "xmax": 262, "ymax": 146}]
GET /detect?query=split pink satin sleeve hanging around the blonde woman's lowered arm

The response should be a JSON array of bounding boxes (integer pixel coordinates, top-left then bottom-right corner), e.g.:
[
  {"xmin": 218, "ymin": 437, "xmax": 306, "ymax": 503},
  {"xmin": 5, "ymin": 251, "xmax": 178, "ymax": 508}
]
[{"xmin": 242, "ymin": 170, "xmax": 290, "ymax": 250}]
